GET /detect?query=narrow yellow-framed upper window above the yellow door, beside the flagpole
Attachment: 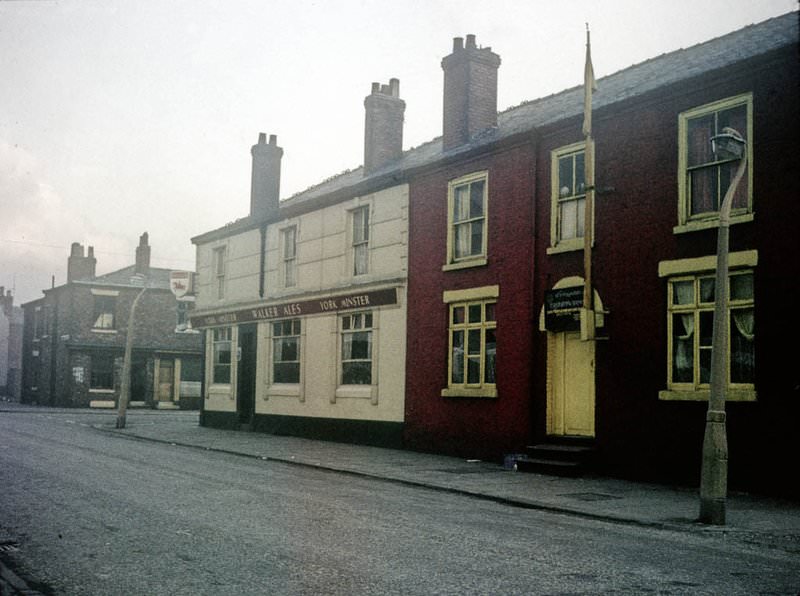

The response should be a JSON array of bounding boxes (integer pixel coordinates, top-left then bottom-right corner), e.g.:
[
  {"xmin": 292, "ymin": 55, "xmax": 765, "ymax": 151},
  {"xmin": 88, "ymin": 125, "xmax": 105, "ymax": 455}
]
[{"xmin": 550, "ymin": 143, "xmax": 586, "ymax": 250}]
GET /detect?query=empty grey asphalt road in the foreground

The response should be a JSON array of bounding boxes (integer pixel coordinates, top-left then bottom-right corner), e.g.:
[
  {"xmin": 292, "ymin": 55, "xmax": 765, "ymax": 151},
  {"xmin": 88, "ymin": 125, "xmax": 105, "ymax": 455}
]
[{"xmin": 0, "ymin": 411, "xmax": 800, "ymax": 595}]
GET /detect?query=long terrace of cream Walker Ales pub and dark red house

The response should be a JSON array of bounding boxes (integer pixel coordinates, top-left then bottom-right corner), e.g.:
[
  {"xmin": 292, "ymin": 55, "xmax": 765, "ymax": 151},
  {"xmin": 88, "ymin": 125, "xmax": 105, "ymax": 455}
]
[{"xmin": 194, "ymin": 13, "xmax": 800, "ymax": 493}]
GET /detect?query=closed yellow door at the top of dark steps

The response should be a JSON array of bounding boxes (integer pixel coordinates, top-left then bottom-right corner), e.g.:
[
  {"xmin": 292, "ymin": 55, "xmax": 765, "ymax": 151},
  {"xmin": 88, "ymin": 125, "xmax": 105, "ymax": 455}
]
[{"xmin": 547, "ymin": 333, "xmax": 594, "ymax": 437}]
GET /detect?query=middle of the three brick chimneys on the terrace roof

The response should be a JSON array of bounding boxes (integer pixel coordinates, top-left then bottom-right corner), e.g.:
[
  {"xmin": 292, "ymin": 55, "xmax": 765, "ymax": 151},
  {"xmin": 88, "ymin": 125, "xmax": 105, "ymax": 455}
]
[{"xmin": 364, "ymin": 79, "xmax": 406, "ymax": 176}]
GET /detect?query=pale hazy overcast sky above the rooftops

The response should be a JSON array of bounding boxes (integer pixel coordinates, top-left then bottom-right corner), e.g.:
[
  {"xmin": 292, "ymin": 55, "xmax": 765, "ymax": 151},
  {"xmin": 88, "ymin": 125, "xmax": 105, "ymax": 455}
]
[{"xmin": 0, "ymin": 0, "xmax": 797, "ymax": 304}]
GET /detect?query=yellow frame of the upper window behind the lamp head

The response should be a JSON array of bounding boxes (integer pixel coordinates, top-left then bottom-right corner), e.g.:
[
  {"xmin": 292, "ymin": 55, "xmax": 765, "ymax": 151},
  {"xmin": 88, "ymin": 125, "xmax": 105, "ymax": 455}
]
[{"xmin": 673, "ymin": 93, "xmax": 754, "ymax": 233}]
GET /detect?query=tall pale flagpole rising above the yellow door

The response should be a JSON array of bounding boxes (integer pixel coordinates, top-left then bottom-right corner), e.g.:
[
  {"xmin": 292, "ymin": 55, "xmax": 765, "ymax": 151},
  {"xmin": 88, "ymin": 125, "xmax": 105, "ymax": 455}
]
[{"xmin": 581, "ymin": 23, "xmax": 597, "ymax": 340}]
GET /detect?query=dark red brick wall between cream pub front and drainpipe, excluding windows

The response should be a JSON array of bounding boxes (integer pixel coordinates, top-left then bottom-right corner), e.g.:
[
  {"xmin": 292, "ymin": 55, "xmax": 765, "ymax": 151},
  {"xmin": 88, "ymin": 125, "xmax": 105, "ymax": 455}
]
[{"xmin": 405, "ymin": 144, "xmax": 535, "ymax": 458}]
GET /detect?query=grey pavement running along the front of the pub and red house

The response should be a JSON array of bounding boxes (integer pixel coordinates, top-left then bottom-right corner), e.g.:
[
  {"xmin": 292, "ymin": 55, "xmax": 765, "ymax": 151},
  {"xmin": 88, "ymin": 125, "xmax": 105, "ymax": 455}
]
[{"xmin": 0, "ymin": 404, "xmax": 800, "ymax": 596}]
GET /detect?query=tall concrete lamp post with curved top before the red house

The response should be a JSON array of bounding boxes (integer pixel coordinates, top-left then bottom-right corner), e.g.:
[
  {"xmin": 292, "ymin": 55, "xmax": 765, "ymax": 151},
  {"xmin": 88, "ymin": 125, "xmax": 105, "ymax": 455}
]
[{"xmin": 699, "ymin": 127, "xmax": 747, "ymax": 526}]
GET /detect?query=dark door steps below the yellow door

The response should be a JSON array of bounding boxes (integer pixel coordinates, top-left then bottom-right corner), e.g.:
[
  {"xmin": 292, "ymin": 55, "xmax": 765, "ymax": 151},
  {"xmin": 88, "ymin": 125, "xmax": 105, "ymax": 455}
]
[{"xmin": 515, "ymin": 437, "xmax": 595, "ymax": 476}]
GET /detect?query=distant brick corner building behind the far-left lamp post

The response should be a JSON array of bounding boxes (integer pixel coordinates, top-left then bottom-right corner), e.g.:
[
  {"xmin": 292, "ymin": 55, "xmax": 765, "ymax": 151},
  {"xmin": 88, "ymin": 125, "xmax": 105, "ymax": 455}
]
[{"xmin": 22, "ymin": 233, "xmax": 202, "ymax": 409}]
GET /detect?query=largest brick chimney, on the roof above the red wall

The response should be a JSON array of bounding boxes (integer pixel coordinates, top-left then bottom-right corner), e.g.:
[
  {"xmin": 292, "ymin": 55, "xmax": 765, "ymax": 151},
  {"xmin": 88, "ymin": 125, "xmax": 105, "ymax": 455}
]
[{"xmin": 442, "ymin": 35, "xmax": 500, "ymax": 151}]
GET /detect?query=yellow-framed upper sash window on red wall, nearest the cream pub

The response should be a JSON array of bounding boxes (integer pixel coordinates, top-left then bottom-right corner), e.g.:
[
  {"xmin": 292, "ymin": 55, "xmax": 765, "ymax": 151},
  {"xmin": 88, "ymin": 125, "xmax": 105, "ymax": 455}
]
[{"xmin": 445, "ymin": 172, "xmax": 489, "ymax": 269}]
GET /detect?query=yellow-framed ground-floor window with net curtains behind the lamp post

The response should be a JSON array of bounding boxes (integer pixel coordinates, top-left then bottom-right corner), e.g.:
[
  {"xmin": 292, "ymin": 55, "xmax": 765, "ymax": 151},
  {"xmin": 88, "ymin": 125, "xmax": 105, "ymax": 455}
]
[{"xmin": 667, "ymin": 270, "xmax": 755, "ymax": 391}]
